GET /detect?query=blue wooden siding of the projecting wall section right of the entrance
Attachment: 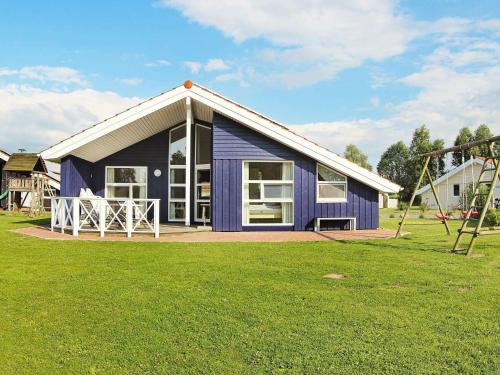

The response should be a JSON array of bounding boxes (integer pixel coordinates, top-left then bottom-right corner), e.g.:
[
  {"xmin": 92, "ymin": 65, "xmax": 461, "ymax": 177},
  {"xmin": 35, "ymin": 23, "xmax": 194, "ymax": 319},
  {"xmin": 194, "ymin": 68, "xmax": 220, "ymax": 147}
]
[{"xmin": 212, "ymin": 113, "xmax": 378, "ymax": 231}]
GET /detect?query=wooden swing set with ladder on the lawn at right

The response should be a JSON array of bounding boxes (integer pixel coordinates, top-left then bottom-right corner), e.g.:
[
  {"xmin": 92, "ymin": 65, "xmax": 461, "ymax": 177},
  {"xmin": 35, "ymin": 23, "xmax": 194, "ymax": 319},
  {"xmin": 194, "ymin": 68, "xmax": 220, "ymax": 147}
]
[{"xmin": 395, "ymin": 136, "xmax": 500, "ymax": 256}]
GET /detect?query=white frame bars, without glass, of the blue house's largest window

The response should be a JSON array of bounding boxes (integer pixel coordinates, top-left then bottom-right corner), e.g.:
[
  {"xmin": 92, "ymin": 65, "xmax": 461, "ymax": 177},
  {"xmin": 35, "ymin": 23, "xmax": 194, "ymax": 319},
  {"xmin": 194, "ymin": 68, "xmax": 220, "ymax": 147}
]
[{"xmin": 241, "ymin": 160, "xmax": 295, "ymax": 227}]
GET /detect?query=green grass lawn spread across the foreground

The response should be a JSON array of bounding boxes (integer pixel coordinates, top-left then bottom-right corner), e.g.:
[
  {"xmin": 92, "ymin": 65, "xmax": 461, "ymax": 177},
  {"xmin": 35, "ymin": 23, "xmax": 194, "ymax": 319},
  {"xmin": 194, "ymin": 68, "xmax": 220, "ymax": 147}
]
[{"xmin": 0, "ymin": 215, "xmax": 500, "ymax": 374}]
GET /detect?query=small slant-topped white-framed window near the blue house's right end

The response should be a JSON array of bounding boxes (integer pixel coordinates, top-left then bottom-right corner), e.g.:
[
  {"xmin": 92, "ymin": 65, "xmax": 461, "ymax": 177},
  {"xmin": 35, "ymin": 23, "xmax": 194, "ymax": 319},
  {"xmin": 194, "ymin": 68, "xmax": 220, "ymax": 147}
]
[{"xmin": 316, "ymin": 164, "xmax": 347, "ymax": 202}]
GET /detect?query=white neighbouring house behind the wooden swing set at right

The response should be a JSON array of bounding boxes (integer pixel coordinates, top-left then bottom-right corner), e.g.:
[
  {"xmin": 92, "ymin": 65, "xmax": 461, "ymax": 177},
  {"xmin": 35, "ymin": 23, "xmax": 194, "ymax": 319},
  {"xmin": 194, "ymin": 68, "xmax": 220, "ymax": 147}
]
[{"xmin": 416, "ymin": 158, "xmax": 500, "ymax": 210}]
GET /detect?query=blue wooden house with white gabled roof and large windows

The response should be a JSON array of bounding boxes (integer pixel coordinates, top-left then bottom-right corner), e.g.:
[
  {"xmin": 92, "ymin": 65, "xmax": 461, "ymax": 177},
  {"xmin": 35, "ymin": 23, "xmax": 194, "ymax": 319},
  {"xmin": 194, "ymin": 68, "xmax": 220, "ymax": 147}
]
[{"xmin": 42, "ymin": 81, "xmax": 400, "ymax": 231}]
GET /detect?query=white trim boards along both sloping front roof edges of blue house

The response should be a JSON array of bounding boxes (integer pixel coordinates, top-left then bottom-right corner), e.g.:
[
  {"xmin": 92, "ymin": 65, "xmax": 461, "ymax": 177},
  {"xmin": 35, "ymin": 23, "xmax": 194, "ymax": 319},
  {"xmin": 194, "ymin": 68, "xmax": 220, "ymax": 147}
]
[{"xmin": 42, "ymin": 84, "xmax": 401, "ymax": 193}]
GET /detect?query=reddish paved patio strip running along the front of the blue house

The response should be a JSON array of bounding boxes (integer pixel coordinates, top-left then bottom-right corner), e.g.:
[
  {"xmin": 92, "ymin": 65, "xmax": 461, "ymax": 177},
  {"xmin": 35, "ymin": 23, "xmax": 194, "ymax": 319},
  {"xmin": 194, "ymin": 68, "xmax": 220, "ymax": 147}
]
[{"xmin": 14, "ymin": 226, "xmax": 396, "ymax": 242}]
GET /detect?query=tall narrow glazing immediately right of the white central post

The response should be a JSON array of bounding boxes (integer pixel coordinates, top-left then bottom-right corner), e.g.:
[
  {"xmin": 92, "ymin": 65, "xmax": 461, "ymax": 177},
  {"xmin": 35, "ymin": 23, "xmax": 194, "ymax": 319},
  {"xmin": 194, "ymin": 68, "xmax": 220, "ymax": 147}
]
[{"xmin": 194, "ymin": 124, "xmax": 212, "ymax": 223}]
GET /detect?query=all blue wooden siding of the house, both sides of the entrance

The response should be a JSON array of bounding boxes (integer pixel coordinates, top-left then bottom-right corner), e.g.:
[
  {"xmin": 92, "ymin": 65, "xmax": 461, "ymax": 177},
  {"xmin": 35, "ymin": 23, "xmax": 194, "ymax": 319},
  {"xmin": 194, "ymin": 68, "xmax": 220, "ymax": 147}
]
[{"xmin": 61, "ymin": 113, "xmax": 378, "ymax": 231}]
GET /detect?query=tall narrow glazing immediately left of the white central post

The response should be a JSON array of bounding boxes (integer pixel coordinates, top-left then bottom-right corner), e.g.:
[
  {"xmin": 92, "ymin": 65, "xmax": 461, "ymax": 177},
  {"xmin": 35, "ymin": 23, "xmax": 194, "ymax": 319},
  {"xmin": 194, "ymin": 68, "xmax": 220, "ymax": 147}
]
[{"xmin": 168, "ymin": 125, "xmax": 186, "ymax": 221}]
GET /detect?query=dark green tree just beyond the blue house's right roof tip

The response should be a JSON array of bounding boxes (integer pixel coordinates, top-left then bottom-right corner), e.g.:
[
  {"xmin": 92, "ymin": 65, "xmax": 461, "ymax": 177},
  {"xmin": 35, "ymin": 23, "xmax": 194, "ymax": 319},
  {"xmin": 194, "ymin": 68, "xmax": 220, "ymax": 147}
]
[{"xmin": 377, "ymin": 141, "xmax": 411, "ymax": 195}]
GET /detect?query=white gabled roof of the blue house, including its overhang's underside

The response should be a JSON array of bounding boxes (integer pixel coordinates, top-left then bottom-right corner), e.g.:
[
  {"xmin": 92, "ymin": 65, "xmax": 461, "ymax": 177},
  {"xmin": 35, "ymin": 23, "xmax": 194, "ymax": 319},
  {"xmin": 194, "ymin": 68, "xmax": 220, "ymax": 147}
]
[{"xmin": 42, "ymin": 81, "xmax": 400, "ymax": 193}]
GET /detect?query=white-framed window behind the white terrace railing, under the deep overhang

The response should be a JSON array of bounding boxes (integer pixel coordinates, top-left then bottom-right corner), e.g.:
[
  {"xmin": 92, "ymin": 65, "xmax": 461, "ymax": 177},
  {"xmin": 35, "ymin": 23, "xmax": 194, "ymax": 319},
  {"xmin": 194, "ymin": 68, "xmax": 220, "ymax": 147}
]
[{"xmin": 105, "ymin": 167, "xmax": 148, "ymax": 199}]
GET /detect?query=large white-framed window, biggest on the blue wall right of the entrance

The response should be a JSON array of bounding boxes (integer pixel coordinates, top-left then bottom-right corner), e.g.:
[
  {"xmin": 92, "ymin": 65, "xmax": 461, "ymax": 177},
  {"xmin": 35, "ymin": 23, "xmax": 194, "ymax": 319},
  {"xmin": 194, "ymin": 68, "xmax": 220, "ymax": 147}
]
[{"xmin": 243, "ymin": 161, "xmax": 293, "ymax": 225}]
